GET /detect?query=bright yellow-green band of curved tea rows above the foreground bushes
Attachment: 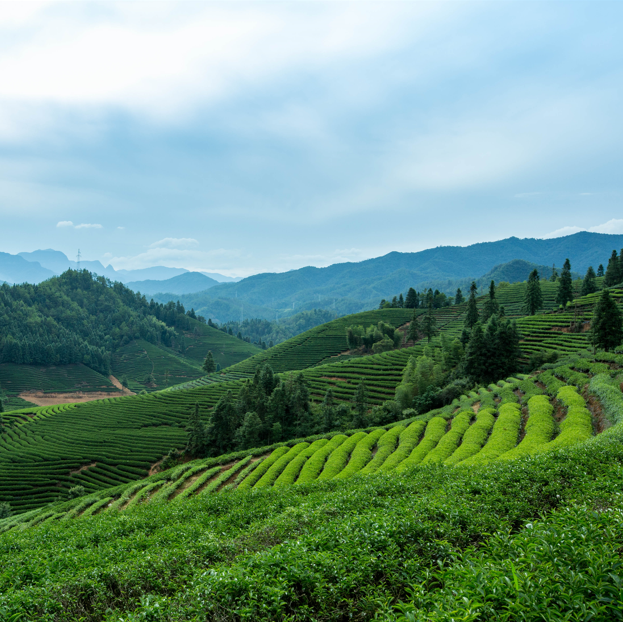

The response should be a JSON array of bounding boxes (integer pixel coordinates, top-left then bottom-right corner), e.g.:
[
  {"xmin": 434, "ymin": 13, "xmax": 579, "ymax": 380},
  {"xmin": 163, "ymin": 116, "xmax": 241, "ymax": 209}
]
[{"xmin": 0, "ymin": 353, "xmax": 623, "ymax": 530}]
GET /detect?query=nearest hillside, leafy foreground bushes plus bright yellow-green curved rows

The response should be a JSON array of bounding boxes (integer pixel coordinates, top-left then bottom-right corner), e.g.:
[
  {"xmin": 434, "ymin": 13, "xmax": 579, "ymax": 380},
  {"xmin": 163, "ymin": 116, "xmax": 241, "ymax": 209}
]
[{"xmin": 0, "ymin": 353, "xmax": 623, "ymax": 622}]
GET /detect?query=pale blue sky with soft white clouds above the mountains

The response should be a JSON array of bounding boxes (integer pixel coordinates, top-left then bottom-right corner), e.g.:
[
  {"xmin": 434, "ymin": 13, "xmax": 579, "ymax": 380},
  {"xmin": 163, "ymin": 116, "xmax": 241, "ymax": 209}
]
[{"xmin": 0, "ymin": 0, "xmax": 623, "ymax": 277}]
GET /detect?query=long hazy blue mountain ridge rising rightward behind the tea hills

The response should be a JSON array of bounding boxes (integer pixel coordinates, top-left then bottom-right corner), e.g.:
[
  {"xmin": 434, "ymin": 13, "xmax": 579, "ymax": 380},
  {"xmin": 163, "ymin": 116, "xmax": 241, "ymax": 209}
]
[{"xmin": 158, "ymin": 232, "xmax": 623, "ymax": 321}]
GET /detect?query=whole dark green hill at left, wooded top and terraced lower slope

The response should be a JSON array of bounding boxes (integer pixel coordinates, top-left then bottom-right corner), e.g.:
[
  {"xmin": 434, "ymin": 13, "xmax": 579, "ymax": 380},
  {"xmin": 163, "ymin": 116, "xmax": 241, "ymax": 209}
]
[{"xmin": 0, "ymin": 270, "xmax": 260, "ymax": 405}]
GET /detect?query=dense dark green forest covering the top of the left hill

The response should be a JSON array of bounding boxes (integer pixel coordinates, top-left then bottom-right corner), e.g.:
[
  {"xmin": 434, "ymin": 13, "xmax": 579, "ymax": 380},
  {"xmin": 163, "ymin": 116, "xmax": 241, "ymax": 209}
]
[{"xmin": 0, "ymin": 270, "xmax": 217, "ymax": 375}]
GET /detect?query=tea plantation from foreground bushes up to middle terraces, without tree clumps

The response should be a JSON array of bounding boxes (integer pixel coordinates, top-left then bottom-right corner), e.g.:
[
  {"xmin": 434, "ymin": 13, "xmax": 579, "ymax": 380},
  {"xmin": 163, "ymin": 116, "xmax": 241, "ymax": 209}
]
[{"xmin": 0, "ymin": 283, "xmax": 623, "ymax": 622}]
